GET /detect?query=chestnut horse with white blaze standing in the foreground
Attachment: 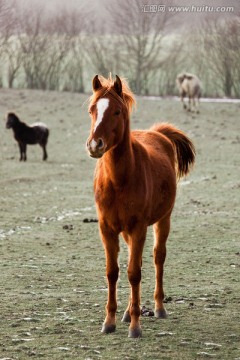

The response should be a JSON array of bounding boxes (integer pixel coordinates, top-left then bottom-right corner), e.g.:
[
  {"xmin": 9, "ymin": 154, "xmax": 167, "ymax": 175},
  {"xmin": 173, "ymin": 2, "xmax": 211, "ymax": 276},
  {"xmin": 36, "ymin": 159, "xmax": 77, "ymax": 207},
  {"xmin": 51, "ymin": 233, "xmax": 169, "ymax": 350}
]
[{"xmin": 87, "ymin": 75, "xmax": 195, "ymax": 338}]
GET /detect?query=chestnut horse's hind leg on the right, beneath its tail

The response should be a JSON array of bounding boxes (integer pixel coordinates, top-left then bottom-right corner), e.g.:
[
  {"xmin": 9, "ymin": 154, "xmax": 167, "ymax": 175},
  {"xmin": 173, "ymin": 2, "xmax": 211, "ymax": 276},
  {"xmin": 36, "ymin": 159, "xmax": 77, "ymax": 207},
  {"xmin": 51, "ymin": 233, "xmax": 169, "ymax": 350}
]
[{"xmin": 154, "ymin": 216, "xmax": 170, "ymax": 318}]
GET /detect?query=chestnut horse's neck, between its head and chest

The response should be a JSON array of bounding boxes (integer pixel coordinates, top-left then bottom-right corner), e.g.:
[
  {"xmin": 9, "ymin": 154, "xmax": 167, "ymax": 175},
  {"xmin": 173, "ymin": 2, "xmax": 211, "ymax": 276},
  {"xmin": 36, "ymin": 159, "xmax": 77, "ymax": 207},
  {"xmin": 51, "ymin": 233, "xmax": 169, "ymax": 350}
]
[{"xmin": 104, "ymin": 121, "xmax": 134, "ymax": 187}]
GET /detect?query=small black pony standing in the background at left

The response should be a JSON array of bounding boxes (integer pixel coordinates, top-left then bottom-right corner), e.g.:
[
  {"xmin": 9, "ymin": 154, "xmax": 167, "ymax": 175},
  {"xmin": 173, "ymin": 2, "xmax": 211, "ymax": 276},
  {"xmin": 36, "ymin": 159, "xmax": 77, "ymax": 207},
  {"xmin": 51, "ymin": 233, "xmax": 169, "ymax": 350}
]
[{"xmin": 6, "ymin": 113, "xmax": 49, "ymax": 161}]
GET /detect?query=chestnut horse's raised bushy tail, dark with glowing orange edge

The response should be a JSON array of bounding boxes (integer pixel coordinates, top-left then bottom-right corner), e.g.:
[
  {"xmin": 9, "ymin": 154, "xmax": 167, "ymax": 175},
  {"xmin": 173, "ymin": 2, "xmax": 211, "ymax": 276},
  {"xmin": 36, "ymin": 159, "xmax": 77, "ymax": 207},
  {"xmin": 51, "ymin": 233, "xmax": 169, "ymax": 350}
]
[{"xmin": 152, "ymin": 123, "xmax": 196, "ymax": 178}]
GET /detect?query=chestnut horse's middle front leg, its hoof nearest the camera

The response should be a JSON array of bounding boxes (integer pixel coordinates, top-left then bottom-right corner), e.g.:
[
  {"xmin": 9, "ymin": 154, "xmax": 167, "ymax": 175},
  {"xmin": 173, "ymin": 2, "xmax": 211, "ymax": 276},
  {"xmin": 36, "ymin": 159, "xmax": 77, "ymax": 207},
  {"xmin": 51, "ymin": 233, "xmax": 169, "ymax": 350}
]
[{"xmin": 125, "ymin": 226, "xmax": 147, "ymax": 338}]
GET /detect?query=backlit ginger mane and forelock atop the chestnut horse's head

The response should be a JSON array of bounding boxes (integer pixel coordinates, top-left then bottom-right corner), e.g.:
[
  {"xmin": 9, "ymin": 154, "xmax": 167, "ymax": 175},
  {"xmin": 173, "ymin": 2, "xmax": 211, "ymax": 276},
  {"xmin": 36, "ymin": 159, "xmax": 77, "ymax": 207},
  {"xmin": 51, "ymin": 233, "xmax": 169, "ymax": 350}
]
[{"xmin": 89, "ymin": 74, "xmax": 136, "ymax": 114}]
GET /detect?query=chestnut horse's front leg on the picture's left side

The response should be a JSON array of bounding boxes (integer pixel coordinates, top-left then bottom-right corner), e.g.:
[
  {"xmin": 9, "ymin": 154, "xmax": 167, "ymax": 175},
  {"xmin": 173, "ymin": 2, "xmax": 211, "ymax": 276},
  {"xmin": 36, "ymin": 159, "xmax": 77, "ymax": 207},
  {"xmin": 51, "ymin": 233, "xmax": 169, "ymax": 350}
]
[{"xmin": 100, "ymin": 223, "xmax": 119, "ymax": 334}]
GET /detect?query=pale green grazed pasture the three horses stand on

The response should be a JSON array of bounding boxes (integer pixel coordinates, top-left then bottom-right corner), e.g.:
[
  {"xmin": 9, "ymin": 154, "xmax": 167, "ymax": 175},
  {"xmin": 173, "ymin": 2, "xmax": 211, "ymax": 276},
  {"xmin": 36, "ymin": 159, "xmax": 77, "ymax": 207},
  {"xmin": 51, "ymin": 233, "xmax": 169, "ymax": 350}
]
[{"xmin": 0, "ymin": 89, "xmax": 240, "ymax": 360}]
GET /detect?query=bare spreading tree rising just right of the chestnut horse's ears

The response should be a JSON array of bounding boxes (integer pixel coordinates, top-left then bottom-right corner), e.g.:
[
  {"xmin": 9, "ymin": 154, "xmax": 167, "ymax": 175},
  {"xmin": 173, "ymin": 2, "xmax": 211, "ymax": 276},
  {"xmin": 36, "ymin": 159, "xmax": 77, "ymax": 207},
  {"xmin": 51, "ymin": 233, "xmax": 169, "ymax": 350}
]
[{"xmin": 104, "ymin": 0, "xmax": 177, "ymax": 94}]
